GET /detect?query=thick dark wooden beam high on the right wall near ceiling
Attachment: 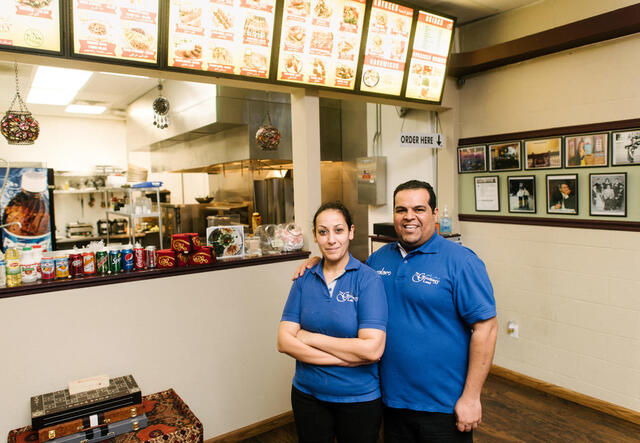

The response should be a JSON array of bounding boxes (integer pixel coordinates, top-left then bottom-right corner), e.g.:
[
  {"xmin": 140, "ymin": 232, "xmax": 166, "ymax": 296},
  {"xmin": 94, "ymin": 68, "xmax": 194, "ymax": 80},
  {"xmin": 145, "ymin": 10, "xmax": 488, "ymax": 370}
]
[{"xmin": 447, "ymin": 4, "xmax": 640, "ymax": 77}]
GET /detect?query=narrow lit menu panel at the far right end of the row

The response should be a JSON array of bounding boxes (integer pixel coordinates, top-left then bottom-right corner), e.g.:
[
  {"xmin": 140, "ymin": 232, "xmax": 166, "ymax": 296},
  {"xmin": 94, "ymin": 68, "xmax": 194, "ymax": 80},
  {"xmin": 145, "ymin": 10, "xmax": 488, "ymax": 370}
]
[{"xmin": 405, "ymin": 11, "xmax": 453, "ymax": 102}]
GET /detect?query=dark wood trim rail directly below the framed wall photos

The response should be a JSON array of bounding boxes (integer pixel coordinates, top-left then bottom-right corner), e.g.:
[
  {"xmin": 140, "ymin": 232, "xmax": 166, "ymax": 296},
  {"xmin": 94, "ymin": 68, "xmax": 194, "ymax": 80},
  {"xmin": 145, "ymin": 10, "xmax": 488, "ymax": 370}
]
[{"xmin": 458, "ymin": 214, "xmax": 640, "ymax": 232}]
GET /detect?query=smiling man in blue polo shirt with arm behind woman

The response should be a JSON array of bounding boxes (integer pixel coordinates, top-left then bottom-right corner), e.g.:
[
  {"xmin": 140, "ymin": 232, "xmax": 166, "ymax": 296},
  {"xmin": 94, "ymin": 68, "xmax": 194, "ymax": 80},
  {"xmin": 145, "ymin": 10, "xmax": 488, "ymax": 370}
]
[{"xmin": 367, "ymin": 180, "xmax": 497, "ymax": 443}]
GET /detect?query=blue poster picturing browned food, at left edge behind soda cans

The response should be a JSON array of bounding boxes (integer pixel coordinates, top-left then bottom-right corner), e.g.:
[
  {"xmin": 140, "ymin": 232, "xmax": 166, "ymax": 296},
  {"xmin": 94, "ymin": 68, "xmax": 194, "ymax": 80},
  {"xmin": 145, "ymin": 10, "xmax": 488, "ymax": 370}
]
[{"xmin": 0, "ymin": 167, "xmax": 51, "ymax": 251}]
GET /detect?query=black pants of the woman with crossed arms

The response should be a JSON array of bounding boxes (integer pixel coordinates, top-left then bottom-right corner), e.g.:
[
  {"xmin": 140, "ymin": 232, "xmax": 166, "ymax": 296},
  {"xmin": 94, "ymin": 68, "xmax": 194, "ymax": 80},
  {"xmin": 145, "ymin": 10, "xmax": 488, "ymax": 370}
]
[{"xmin": 291, "ymin": 386, "xmax": 382, "ymax": 443}]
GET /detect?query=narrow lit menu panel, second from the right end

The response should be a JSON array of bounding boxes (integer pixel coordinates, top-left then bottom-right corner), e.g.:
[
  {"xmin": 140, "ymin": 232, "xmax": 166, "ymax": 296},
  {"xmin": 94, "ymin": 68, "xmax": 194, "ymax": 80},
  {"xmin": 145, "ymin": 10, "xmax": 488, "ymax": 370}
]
[{"xmin": 360, "ymin": 0, "xmax": 413, "ymax": 95}]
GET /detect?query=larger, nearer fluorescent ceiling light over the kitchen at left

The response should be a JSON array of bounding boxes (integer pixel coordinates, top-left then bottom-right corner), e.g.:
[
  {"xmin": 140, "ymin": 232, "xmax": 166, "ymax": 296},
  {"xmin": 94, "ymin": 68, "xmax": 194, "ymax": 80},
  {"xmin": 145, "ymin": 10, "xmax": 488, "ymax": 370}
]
[{"xmin": 27, "ymin": 66, "xmax": 93, "ymax": 105}]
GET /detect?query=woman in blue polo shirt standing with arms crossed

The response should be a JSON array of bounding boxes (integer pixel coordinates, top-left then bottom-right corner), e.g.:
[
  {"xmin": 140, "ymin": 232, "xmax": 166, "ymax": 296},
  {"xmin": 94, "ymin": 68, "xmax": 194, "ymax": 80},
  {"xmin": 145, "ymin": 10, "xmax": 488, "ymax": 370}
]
[{"xmin": 278, "ymin": 202, "xmax": 387, "ymax": 443}]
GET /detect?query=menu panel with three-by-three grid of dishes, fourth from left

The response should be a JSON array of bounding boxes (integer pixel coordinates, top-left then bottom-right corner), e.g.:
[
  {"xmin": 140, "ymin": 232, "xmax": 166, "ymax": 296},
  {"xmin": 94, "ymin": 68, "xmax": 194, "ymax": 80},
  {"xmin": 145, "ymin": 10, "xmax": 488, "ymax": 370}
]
[{"xmin": 278, "ymin": 0, "xmax": 366, "ymax": 90}]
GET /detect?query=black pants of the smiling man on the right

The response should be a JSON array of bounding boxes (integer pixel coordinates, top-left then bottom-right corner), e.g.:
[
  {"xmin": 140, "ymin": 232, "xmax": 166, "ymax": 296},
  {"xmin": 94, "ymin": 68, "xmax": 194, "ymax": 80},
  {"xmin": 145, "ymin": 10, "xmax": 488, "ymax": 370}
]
[{"xmin": 384, "ymin": 406, "xmax": 473, "ymax": 443}]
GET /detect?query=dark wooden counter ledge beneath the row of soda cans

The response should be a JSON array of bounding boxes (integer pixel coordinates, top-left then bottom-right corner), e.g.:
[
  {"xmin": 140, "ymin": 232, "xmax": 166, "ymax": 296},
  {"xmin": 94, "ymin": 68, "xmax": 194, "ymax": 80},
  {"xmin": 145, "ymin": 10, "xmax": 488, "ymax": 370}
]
[{"xmin": 0, "ymin": 251, "xmax": 309, "ymax": 299}]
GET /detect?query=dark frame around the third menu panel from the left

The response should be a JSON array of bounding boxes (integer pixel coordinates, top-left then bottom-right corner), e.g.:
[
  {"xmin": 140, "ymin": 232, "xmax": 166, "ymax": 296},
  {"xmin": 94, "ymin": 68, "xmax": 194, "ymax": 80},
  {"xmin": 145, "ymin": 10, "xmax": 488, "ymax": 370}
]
[{"xmin": 161, "ymin": 0, "xmax": 282, "ymax": 86}]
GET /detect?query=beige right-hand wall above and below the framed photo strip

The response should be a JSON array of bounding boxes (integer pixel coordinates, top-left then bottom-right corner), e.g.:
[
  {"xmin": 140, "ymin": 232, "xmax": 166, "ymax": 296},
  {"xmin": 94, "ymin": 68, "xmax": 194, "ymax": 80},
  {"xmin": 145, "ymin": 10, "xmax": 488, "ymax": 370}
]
[{"xmin": 459, "ymin": 0, "xmax": 640, "ymax": 410}]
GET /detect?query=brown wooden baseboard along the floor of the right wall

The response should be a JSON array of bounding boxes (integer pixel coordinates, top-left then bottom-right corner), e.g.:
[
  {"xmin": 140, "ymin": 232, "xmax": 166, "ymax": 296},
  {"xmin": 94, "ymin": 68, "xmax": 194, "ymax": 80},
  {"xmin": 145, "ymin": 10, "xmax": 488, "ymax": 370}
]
[{"xmin": 491, "ymin": 365, "xmax": 640, "ymax": 424}]
